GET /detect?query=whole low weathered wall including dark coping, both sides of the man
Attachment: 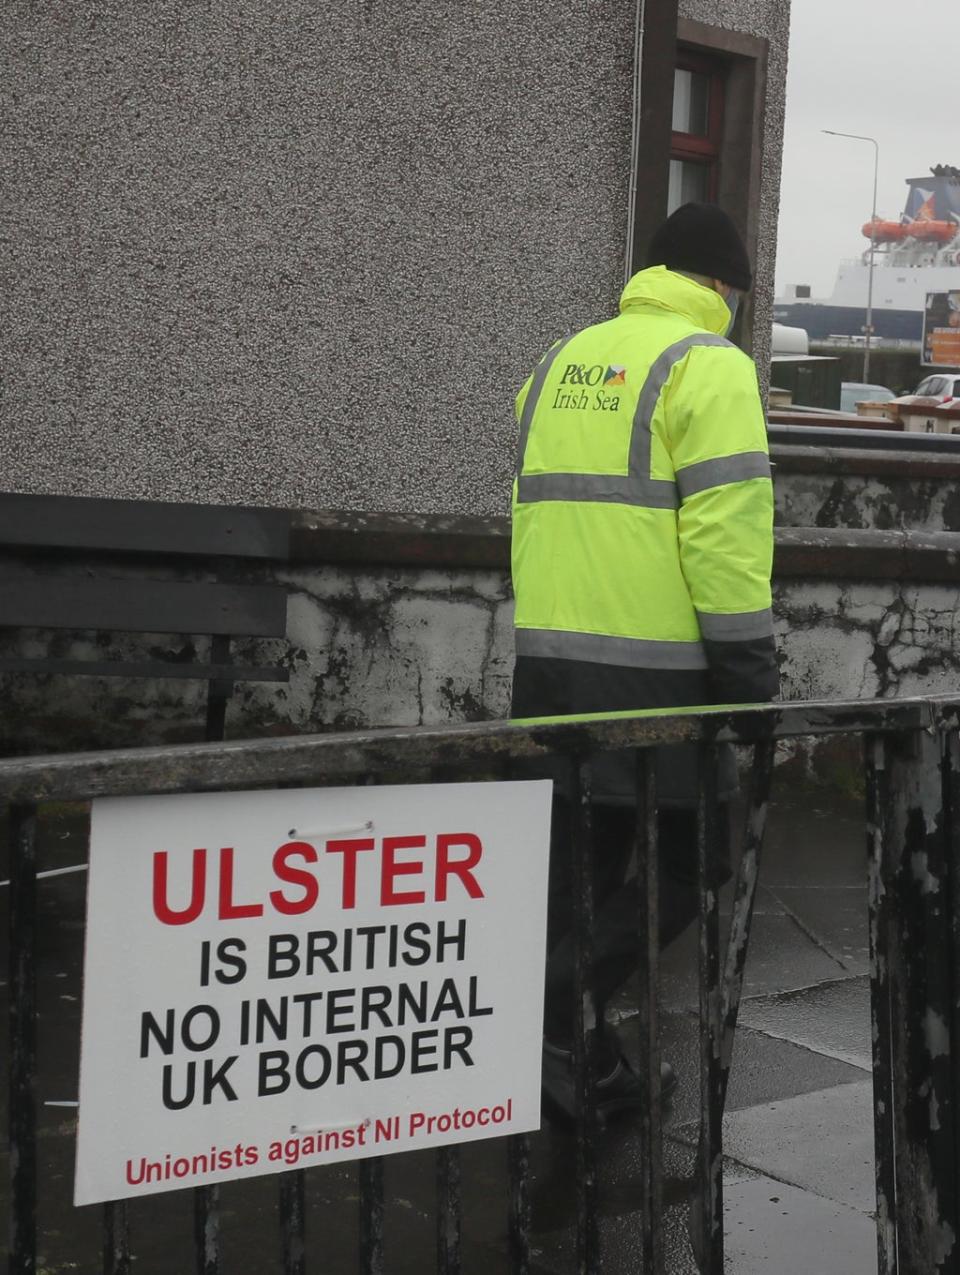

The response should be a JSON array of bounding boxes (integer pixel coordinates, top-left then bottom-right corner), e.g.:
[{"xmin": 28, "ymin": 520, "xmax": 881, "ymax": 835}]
[{"xmin": 7, "ymin": 445, "xmax": 960, "ymax": 750}]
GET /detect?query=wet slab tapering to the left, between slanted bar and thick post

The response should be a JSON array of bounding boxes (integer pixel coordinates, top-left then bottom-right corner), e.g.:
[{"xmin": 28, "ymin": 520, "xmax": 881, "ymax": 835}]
[{"xmin": 739, "ymin": 975, "xmax": 872, "ymax": 1071}]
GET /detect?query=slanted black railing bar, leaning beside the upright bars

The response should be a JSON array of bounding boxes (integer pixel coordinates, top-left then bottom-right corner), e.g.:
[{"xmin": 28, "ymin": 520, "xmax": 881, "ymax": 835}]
[{"xmin": 720, "ymin": 740, "xmax": 776, "ymax": 1114}]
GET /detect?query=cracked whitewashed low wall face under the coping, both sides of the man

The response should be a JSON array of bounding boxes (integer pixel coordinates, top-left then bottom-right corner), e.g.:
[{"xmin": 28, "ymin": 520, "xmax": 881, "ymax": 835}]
[{"xmin": 7, "ymin": 537, "xmax": 960, "ymax": 751}]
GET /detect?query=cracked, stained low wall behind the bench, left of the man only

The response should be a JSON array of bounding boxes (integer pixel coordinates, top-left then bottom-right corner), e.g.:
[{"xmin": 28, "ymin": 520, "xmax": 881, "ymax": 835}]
[{"xmin": 0, "ymin": 556, "xmax": 514, "ymax": 752}]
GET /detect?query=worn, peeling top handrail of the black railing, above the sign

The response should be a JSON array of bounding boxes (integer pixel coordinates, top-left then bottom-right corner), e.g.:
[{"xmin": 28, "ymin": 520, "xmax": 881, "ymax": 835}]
[{"xmin": 0, "ymin": 695, "xmax": 960, "ymax": 805}]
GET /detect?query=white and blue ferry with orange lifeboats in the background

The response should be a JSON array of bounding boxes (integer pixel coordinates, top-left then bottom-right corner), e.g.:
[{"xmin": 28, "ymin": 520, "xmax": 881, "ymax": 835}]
[{"xmin": 774, "ymin": 164, "xmax": 960, "ymax": 346}]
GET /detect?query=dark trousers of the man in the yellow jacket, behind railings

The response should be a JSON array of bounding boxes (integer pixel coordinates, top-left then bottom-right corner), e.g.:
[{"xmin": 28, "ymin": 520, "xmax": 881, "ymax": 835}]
[{"xmin": 544, "ymin": 797, "xmax": 731, "ymax": 1048}]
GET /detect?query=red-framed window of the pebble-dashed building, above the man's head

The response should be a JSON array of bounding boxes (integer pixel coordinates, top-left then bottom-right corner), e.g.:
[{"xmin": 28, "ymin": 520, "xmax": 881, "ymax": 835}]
[{"xmin": 667, "ymin": 50, "xmax": 723, "ymax": 213}]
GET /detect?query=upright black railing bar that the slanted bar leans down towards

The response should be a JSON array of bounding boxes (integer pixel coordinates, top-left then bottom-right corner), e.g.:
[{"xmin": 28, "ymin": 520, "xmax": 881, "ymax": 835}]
[{"xmin": 697, "ymin": 745, "xmax": 723, "ymax": 1275}]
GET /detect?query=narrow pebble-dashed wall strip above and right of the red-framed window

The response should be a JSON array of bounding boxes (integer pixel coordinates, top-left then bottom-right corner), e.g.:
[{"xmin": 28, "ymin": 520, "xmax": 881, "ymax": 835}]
[{"xmin": 680, "ymin": 0, "xmax": 790, "ymax": 385}]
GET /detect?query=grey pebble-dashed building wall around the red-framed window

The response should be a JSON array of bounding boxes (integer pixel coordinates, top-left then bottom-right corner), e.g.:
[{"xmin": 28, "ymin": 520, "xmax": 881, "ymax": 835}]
[{"xmin": 0, "ymin": 0, "xmax": 787, "ymax": 513}]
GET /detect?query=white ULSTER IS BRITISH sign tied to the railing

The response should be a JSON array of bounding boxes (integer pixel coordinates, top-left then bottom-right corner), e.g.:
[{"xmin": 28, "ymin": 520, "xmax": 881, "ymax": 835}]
[{"xmin": 75, "ymin": 780, "xmax": 551, "ymax": 1205}]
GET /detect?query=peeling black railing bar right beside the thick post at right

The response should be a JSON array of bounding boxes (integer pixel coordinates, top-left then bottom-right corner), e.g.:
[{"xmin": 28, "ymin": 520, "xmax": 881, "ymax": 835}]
[{"xmin": 863, "ymin": 734, "xmax": 898, "ymax": 1275}]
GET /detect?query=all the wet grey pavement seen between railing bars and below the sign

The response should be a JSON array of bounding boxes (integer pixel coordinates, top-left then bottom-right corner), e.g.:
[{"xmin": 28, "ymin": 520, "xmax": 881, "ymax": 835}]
[{"xmin": 0, "ymin": 785, "xmax": 876, "ymax": 1275}]
